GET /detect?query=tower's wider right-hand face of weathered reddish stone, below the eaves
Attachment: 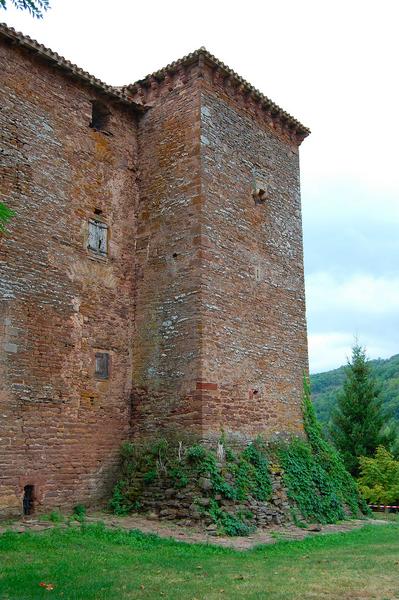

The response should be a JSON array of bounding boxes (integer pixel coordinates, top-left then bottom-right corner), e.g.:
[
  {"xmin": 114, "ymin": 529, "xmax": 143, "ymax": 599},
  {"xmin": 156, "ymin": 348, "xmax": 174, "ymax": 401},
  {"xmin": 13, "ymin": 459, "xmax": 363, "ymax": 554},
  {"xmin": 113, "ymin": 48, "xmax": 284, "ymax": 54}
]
[{"xmin": 201, "ymin": 78, "xmax": 307, "ymax": 437}]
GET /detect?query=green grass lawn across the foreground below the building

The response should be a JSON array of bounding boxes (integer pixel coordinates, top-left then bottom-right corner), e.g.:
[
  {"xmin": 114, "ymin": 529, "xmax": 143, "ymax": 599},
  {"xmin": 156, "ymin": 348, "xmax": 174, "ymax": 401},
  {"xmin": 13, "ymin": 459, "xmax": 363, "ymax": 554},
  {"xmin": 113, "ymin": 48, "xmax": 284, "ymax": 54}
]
[{"xmin": 0, "ymin": 523, "xmax": 399, "ymax": 600}]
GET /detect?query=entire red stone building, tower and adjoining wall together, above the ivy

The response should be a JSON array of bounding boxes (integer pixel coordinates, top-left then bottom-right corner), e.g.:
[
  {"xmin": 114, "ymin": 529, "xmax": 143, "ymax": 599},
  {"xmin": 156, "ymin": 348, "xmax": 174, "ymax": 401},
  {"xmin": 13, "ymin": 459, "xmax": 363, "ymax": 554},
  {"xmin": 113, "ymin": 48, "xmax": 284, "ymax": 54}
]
[{"xmin": 0, "ymin": 26, "xmax": 308, "ymax": 515}]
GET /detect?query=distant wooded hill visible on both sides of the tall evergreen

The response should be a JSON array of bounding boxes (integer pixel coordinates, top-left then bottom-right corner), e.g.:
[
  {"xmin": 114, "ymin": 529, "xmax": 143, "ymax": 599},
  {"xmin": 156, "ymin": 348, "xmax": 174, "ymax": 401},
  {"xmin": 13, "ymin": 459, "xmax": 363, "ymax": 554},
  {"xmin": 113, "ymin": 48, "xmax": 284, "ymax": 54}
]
[{"xmin": 310, "ymin": 354, "xmax": 399, "ymax": 423}]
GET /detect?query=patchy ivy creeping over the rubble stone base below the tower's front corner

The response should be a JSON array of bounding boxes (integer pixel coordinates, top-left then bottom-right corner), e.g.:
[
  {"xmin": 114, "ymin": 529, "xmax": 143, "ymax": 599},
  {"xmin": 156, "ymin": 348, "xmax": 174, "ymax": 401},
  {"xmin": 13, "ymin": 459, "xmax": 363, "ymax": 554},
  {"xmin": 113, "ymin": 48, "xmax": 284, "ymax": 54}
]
[{"xmin": 109, "ymin": 438, "xmax": 272, "ymax": 535}]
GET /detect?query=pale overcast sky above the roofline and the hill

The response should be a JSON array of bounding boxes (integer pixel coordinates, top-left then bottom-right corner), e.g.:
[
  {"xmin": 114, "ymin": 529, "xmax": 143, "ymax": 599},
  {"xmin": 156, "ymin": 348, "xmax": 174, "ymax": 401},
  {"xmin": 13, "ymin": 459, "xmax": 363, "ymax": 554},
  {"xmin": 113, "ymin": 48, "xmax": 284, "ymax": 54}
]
[{"xmin": 0, "ymin": 0, "xmax": 399, "ymax": 372}]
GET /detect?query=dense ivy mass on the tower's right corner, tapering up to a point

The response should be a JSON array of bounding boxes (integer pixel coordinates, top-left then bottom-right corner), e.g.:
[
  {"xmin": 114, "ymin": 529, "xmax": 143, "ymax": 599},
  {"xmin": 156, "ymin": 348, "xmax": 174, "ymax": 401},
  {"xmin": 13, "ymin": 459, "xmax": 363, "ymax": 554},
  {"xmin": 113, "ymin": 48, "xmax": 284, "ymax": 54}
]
[{"xmin": 278, "ymin": 378, "xmax": 368, "ymax": 523}]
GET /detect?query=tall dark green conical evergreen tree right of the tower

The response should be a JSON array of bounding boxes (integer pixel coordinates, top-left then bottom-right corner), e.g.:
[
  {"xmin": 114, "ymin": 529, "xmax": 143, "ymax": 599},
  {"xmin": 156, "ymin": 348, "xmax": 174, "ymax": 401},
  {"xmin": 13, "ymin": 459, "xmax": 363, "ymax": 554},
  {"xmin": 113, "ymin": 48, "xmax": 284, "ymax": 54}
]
[{"xmin": 331, "ymin": 342, "xmax": 387, "ymax": 476}]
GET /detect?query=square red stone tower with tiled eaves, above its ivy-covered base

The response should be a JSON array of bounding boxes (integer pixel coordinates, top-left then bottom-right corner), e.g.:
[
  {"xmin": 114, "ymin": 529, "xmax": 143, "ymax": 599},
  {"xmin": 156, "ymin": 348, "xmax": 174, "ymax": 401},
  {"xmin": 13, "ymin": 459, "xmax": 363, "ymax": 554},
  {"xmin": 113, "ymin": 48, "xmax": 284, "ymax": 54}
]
[{"xmin": 129, "ymin": 49, "xmax": 308, "ymax": 446}]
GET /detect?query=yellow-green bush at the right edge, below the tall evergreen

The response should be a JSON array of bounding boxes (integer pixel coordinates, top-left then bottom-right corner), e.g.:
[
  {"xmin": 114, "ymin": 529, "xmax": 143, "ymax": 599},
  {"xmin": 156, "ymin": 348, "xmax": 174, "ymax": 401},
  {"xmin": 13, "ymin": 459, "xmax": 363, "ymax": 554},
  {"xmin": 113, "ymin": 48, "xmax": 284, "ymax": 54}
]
[{"xmin": 358, "ymin": 446, "xmax": 399, "ymax": 505}]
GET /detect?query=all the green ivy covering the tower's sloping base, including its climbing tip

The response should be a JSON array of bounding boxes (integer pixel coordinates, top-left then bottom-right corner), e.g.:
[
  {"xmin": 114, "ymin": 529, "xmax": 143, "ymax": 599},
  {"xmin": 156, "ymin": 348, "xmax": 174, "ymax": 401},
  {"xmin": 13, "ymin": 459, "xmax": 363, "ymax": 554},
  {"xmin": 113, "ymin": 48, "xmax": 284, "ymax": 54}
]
[{"xmin": 110, "ymin": 379, "xmax": 368, "ymax": 535}]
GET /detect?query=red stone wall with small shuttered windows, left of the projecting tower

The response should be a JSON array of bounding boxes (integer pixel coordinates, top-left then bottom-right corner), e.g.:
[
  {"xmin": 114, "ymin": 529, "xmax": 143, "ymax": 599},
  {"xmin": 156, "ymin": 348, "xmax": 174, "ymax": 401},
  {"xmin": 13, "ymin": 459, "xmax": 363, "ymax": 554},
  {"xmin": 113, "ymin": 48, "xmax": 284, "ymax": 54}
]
[{"xmin": 0, "ymin": 42, "xmax": 137, "ymax": 515}]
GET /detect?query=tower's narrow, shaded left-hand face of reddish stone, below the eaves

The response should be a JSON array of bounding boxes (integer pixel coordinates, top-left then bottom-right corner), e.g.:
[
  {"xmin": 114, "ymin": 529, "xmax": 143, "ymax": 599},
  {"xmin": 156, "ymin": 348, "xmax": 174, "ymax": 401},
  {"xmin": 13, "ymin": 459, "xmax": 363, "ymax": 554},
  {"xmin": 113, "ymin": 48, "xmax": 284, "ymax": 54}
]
[{"xmin": 132, "ymin": 73, "xmax": 202, "ymax": 436}]
